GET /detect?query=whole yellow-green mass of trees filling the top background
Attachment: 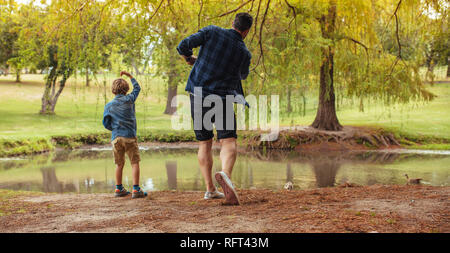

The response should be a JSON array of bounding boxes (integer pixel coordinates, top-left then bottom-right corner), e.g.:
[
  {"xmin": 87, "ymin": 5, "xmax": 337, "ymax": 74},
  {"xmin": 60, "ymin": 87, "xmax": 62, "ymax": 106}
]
[{"xmin": 0, "ymin": 0, "xmax": 450, "ymax": 130}]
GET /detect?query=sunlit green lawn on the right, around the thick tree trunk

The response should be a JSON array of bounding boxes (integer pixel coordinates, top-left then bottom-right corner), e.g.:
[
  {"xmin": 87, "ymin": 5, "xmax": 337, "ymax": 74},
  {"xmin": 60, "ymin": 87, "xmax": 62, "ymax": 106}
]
[{"xmin": 280, "ymin": 81, "xmax": 450, "ymax": 140}]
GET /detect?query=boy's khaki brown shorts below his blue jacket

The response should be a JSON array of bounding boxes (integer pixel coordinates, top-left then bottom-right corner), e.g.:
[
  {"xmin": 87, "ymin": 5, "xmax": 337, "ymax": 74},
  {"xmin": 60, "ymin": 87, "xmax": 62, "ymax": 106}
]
[{"xmin": 111, "ymin": 137, "xmax": 141, "ymax": 166}]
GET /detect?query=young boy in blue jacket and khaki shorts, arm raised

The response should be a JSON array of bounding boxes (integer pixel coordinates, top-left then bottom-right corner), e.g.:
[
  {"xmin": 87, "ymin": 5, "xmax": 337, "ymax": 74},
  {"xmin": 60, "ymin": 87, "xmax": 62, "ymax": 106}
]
[{"xmin": 103, "ymin": 71, "xmax": 147, "ymax": 198}]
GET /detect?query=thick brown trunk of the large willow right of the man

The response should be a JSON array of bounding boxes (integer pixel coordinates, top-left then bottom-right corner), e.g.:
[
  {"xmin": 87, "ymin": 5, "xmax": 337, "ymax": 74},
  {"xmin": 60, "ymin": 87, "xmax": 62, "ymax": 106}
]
[{"xmin": 311, "ymin": 1, "xmax": 342, "ymax": 131}]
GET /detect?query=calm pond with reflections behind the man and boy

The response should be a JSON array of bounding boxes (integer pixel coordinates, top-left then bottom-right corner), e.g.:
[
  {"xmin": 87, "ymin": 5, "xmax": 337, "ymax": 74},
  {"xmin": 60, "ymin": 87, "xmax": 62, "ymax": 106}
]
[{"xmin": 0, "ymin": 147, "xmax": 450, "ymax": 193}]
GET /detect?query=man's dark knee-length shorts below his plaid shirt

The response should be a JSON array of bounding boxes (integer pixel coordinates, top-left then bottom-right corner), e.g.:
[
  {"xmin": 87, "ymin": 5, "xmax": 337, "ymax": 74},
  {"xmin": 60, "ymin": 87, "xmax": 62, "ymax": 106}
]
[{"xmin": 190, "ymin": 94, "xmax": 237, "ymax": 141}]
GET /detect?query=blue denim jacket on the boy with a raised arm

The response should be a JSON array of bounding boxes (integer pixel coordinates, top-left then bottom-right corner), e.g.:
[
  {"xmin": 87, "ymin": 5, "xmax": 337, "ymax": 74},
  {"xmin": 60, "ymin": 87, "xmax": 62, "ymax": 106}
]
[{"xmin": 103, "ymin": 78, "xmax": 141, "ymax": 141}]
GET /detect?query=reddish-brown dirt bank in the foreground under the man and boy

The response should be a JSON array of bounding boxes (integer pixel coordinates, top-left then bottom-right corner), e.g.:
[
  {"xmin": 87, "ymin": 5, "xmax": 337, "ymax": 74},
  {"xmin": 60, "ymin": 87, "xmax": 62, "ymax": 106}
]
[{"xmin": 0, "ymin": 185, "xmax": 450, "ymax": 233}]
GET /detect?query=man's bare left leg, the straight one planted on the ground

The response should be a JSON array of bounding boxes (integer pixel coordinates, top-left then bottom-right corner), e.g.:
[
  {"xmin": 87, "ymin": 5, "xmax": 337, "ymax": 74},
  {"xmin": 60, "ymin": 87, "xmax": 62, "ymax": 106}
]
[{"xmin": 198, "ymin": 139, "xmax": 216, "ymax": 192}]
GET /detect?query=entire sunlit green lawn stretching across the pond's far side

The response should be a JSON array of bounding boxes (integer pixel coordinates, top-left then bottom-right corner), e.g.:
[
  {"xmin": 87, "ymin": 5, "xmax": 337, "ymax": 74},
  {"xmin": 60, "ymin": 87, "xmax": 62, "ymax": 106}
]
[{"xmin": 0, "ymin": 71, "xmax": 450, "ymax": 146}]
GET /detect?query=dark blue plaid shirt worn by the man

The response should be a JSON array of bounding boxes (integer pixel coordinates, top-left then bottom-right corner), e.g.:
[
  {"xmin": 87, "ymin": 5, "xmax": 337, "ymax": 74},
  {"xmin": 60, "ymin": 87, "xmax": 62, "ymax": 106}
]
[{"xmin": 177, "ymin": 25, "xmax": 252, "ymax": 98}]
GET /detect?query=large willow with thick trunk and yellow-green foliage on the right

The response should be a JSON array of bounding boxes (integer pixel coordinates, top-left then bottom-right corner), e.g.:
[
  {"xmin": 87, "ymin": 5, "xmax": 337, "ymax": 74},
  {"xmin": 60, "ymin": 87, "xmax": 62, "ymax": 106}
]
[{"xmin": 285, "ymin": 0, "xmax": 442, "ymax": 131}]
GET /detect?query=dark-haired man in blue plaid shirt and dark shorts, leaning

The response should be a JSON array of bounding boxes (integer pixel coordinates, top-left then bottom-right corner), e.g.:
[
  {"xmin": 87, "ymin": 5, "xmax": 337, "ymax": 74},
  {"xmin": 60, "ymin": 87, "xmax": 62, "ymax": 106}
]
[{"xmin": 177, "ymin": 13, "xmax": 253, "ymax": 205}]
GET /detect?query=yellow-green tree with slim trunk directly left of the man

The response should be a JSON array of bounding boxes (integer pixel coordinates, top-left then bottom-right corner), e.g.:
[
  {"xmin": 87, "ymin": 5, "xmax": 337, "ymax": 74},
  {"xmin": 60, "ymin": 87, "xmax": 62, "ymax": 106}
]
[{"xmin": 137, "ymin": 0, "xmax": 208, "ymax": 114}]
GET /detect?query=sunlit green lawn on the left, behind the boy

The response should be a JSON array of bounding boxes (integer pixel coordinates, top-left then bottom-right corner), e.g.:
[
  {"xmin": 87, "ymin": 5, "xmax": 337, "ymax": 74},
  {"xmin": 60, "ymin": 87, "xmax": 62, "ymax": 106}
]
[{"xmin": 0, "ymin": 75, "xmax": 171, "ymax": 139}]
